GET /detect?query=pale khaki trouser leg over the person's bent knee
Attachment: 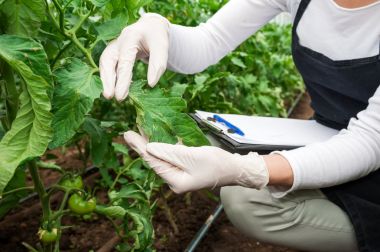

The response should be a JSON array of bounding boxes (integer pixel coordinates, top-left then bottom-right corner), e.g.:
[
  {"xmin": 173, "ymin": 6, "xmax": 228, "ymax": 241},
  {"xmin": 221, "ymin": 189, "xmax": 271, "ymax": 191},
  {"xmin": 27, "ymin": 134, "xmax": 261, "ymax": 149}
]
[{"xmin": 221, "ymin": 186, "xmax": 358, "ymax": 251}]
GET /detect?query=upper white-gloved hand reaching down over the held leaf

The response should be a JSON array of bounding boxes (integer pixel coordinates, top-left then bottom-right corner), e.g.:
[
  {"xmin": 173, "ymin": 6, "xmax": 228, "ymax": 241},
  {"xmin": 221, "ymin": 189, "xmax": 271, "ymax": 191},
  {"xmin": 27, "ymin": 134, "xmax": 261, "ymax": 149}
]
[{"xmin": 100, "ymin": 13, "xmax": 170, "ymax": 101}]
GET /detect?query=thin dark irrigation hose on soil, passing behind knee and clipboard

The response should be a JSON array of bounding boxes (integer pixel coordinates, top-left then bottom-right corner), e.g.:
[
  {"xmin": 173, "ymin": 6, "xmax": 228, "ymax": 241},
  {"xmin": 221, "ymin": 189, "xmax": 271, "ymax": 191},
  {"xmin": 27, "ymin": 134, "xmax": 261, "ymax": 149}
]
[{"xmin": 185, "ymin": 92, "xmax": 304, "ymax": 252}]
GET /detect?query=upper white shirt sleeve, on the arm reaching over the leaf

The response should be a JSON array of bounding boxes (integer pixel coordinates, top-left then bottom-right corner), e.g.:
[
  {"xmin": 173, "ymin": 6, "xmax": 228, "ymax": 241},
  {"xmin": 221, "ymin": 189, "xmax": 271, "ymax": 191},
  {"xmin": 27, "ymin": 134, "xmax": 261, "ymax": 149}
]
[{"xmin": 168, "ymin": 0, "xmax": 289, "ymax": 74}]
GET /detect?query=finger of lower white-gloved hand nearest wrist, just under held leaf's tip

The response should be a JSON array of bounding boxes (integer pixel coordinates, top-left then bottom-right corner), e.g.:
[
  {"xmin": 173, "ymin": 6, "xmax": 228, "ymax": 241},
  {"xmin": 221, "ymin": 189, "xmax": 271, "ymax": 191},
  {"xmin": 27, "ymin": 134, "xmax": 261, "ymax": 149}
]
[{"xmin": 146, "ymin": 143, "xmax": 193, "ymax": 172}]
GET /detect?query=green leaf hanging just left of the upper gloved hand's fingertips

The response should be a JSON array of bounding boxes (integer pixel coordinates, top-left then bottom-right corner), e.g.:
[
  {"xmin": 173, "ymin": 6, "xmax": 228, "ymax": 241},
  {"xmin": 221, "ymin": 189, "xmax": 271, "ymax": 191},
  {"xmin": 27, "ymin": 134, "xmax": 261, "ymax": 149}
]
[{"xmin": 49, "ymin": 58, "xmax": 102, "ymax": 148}]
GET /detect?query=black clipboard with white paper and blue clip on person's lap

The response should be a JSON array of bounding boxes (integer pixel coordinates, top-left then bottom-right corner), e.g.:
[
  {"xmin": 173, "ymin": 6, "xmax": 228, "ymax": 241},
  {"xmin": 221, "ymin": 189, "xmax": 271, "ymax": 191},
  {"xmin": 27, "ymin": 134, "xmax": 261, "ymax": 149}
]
[{"xmin": 190, "ymin": 111, "xmax": 338, "ymax": 154}]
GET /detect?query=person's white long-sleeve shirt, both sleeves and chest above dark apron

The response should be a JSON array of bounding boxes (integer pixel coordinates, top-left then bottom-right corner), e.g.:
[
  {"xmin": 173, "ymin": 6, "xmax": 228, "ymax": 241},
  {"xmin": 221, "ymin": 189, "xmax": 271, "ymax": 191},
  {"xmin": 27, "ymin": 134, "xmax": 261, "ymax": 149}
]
[{"xmin": 168, "ymin": 0, "xmax": 380, "ymax": 197}]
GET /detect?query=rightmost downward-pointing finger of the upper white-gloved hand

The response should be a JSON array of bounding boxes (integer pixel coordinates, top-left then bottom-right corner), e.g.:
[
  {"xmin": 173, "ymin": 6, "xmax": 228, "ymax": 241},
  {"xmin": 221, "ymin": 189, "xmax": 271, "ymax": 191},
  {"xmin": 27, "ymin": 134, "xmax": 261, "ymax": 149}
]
[{"xmin": 146, "ymin": 35, "xmax": 169, "ymax": 87}]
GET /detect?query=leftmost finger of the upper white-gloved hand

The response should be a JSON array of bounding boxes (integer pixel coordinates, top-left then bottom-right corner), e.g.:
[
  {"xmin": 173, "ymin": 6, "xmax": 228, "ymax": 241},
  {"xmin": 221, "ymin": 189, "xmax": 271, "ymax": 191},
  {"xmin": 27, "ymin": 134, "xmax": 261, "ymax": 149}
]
[{"xmin": 99, "ymin": 40, "xmax": 119, "ymax": 99}]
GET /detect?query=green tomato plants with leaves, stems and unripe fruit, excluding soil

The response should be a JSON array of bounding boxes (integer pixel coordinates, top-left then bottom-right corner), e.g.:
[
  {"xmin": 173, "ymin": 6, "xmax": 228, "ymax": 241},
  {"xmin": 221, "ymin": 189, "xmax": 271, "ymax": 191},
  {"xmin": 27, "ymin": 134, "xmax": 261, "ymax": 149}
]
[{"xmin": 0, "ymin": 0, "xmax": 301, "ymax": 251}]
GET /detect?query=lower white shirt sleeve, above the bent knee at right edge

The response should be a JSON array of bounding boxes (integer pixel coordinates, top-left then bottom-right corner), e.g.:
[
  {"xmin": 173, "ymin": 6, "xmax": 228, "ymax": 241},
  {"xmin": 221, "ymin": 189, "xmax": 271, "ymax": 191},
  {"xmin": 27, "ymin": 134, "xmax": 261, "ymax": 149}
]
[{"xmin": 270, "ymin": 86, "xmax": 380, "ymax": 197}]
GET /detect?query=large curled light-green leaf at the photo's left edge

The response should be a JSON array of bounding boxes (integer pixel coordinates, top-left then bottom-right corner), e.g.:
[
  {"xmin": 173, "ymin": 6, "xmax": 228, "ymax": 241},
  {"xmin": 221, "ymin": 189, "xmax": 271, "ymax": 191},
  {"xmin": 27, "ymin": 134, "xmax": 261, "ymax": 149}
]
[{"xmin": 0, "ymin": 35, "xmax": 52, "ymax": 194}]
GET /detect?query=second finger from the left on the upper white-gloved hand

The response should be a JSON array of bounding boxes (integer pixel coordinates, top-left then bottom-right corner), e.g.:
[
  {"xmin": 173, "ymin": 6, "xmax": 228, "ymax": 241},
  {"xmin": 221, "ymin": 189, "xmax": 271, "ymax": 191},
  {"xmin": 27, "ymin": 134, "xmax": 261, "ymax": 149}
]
[{"xmin": 115, "ymin": 33, "xmax": 140, "ymax": 101}]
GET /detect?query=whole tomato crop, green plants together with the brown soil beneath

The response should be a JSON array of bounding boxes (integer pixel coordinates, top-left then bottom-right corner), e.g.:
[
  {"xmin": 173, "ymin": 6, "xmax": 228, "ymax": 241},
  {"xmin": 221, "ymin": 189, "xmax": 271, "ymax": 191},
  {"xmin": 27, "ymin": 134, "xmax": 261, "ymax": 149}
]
[{"xmin": 0, "ymin": 0, "xmax": 302, "ymax": 252}]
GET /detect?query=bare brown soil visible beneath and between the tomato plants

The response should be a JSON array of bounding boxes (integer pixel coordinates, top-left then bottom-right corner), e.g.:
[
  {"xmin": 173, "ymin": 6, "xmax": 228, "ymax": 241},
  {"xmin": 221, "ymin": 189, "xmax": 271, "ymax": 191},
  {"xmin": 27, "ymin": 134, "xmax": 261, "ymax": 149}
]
[{"xmin": 0, "ymin": 95, "xmax": 313, "ymax": 252}]
